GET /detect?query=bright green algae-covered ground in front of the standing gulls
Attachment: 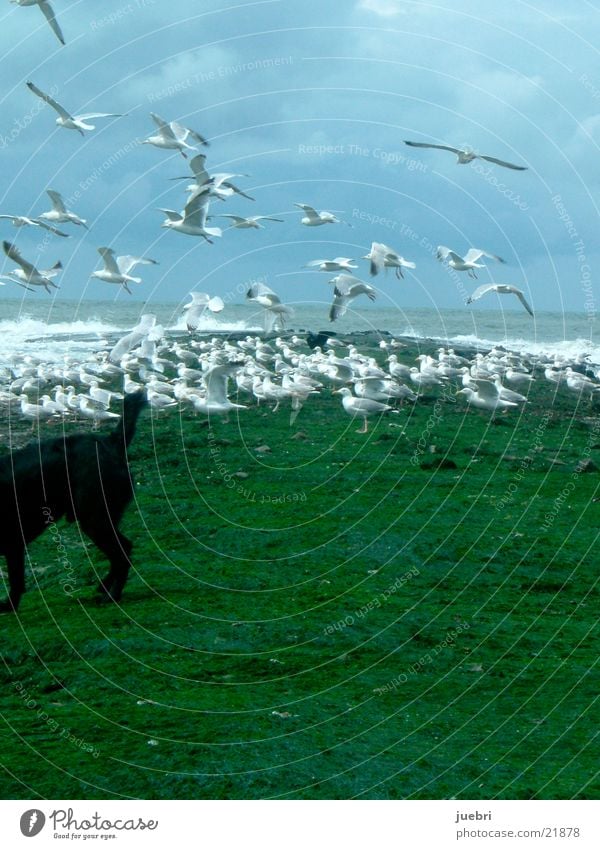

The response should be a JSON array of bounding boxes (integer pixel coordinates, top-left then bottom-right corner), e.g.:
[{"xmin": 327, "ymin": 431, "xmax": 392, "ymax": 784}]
[{"xmin": 0, "ymin": 336, "xmax": 600, "ymax": 799}]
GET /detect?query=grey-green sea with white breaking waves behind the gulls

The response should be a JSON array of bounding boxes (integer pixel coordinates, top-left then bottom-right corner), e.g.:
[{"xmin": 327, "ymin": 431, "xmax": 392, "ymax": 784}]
[{"xmin": 0, "ymin": 298, "xmax": 600, "ymax": 366}]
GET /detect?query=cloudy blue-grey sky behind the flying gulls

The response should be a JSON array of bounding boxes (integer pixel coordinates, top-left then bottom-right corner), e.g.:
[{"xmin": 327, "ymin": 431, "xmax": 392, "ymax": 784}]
[{"xmin": 0, "ymin": 0, "xmax": 600, "ymax": 316}]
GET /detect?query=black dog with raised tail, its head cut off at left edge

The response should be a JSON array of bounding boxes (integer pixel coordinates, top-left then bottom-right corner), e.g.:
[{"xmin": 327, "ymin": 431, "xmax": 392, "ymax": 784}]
[{"xmin": 0, "ymin": 392, "xmax": 146, "ymax": 613}]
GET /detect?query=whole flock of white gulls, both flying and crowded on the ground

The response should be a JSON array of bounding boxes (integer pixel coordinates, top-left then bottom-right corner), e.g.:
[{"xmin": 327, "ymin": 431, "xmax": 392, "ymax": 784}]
[{"xmin": 0, "ymin": 0, "xmax": 580, "ymax": 433}]
